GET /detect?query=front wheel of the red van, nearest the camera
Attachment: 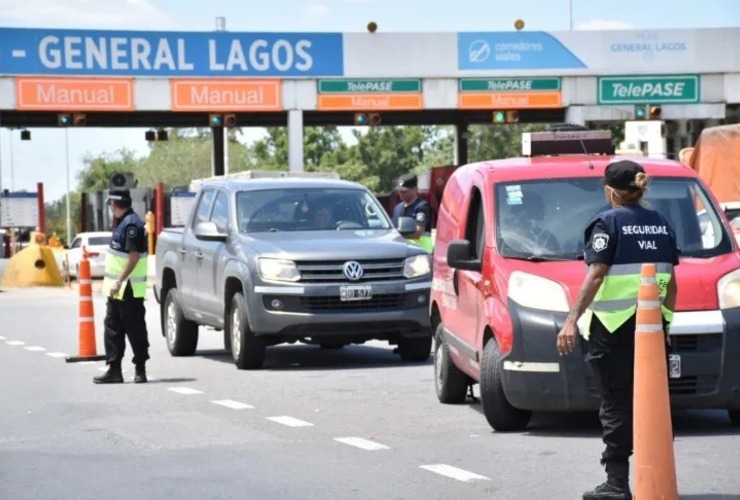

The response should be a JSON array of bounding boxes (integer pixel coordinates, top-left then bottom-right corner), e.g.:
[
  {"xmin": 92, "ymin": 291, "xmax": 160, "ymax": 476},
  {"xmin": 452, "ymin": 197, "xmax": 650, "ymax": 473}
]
[{"xmin": 480, "ymin": 339, "xmax": 532, "ymax": 431}]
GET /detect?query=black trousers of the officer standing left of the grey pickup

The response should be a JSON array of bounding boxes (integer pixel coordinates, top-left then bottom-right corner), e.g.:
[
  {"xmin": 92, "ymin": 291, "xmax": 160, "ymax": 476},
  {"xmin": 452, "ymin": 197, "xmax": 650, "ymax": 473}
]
[{"xmin": 103, "ymin": 283, "xmax": 149, "ymax": 365}]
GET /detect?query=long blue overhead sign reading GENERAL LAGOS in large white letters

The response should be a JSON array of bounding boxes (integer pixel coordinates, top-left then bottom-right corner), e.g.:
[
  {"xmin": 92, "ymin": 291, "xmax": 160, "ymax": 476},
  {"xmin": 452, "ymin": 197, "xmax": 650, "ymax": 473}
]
[{"xmin": 0, "ymin": 28, "xmax": 344, "ymax": 77}]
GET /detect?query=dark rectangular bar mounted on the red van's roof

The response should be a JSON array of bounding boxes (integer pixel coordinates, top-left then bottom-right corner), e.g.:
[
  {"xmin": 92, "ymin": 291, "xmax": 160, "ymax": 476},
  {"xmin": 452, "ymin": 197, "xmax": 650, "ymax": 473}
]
[{"xmin": 522, "ymin": 130, "xmax": 614, "ymax": 156}]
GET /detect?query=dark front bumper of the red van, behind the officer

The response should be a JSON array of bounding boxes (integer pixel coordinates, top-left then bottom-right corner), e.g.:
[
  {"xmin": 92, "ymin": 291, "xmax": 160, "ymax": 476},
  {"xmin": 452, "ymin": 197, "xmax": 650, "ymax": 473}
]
[{"xmin": 502, "ymin": 301, "xmax": 740, "ymax": 411}]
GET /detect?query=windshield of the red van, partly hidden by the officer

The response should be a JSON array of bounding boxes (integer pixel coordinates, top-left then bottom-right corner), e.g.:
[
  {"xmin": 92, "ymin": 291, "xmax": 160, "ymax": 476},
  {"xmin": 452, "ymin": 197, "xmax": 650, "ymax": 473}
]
[{"xmin": 495, "ymin": 177, "xmax": 732, "ymax": 260}]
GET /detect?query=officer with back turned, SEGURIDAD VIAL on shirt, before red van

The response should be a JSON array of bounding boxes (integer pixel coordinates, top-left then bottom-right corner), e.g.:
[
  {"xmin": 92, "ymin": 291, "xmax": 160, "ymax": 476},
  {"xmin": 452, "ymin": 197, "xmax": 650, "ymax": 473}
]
[{"xmin": 557, "ymin": 160, "xmax": 679, "ymax": 500}]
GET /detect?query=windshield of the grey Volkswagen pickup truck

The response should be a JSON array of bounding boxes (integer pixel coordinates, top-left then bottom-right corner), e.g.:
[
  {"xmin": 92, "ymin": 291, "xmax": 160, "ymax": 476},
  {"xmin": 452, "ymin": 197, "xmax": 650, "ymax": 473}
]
[{"xmin": 237, "ymin": 188, "xmax": 391, "ymax": 233}]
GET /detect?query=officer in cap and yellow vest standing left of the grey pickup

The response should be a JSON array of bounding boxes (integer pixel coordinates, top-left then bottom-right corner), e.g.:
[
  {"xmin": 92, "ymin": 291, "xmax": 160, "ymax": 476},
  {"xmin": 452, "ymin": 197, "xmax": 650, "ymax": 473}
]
[{"xmin": 94, "ymin": 188, "xmax": 149, "ymax": 384}]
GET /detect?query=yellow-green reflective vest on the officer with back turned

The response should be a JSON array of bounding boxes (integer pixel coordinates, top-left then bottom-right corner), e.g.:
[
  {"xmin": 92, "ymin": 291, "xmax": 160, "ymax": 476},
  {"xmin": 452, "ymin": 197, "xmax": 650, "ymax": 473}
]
[{"xmin": 578, "ymin": 262, "xmax": 673, "ymax": 340}]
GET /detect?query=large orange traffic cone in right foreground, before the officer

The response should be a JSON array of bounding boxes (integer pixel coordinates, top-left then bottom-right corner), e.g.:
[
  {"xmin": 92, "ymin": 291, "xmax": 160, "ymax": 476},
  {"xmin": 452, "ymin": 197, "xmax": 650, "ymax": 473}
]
[{"xmin": 633, "ymin": 264, "xmax": 678, "ymax": 500}]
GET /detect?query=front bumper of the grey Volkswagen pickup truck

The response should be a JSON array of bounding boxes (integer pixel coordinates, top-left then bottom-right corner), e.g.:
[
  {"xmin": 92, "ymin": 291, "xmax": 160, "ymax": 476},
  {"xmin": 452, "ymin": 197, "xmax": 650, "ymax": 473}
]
[{"xmin": 249, "ymin": 281, "xmax": 431, "ymax": 341}]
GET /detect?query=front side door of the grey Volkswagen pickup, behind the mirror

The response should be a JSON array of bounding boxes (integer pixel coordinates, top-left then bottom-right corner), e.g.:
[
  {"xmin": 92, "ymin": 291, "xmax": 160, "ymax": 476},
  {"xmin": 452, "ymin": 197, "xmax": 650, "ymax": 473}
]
[{"xmin": 198, "ymin": 191, "xmax": 229, "ymax": 322}]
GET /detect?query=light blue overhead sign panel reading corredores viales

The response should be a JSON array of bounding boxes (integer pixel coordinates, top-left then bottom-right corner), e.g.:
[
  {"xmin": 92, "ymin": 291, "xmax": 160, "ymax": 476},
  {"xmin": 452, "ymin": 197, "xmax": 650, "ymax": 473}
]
[{"xmin": 457, "ymin": 31, "xmax": 586, "ymax": 71}]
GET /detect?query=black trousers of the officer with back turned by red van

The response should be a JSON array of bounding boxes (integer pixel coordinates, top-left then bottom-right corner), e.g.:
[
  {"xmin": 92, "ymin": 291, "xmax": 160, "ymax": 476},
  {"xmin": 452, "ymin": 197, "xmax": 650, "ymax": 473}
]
[{"xmin": 586, "ymin": 315, "xmax": 669, "ymax": 467}]
